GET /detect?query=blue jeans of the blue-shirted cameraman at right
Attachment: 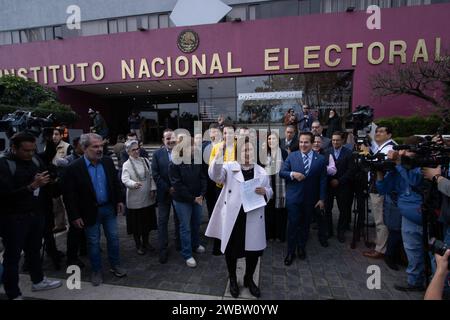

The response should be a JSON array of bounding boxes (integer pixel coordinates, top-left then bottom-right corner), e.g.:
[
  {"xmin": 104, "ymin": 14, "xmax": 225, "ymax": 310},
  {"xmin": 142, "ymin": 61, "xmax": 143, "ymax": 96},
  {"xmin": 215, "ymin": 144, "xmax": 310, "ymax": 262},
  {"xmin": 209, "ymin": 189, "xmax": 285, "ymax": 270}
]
[{"xmin": 402, "ymin": 217, "xmax": 425, "ymax": 286}]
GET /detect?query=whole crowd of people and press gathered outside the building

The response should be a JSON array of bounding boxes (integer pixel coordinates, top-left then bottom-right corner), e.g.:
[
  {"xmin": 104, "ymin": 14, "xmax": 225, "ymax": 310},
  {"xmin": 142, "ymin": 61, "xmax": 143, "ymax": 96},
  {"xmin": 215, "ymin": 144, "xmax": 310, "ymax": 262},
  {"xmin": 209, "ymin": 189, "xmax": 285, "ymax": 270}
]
[{"xmin": 0, "ymin": 105, "xmax": 450, "ymax": 299}]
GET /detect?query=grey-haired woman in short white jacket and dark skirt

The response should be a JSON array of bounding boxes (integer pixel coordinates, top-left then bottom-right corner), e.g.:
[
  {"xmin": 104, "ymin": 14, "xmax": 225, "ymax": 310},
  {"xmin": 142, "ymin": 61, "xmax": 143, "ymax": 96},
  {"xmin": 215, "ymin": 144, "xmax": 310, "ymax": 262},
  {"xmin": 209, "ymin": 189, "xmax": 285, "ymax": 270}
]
[{"xmin": 122, "ymin": 140, "xmax": 157, "ymax": 255}]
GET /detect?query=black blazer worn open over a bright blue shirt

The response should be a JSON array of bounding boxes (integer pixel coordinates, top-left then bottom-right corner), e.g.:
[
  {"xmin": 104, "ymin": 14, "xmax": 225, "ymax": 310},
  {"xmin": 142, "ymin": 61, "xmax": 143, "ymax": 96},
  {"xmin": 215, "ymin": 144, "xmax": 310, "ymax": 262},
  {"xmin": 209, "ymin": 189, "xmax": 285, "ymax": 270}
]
[{"xmin": 63, "ymin": 157, "xmax": 122, "ymax": 226}]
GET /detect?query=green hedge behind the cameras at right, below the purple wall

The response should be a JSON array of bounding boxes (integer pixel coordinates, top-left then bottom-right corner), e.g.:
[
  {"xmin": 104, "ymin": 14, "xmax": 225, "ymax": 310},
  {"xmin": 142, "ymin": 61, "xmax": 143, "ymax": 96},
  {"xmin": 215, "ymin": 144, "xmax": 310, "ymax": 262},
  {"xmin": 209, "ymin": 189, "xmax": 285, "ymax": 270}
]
[{"xmin": 375, "ymin": 115, "xmax": 442, "ymax": 137}]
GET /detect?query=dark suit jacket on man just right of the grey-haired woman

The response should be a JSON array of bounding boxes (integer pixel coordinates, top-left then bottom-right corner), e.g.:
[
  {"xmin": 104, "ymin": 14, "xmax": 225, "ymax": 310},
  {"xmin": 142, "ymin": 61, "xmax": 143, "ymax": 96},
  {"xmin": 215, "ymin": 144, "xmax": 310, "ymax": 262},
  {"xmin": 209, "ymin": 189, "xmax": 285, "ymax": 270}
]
[{"xmin": 152, "ymin": 147, "xmax": 171, "ymax": 202}]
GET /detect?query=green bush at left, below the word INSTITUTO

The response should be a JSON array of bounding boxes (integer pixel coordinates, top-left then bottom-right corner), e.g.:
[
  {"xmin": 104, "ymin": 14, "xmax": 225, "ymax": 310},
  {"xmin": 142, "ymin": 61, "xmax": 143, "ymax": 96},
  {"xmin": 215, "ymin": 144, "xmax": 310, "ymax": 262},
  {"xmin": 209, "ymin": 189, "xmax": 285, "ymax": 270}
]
[{"xmin": 0, "ymin": 75, "xmax": 79, "ymax": 124}]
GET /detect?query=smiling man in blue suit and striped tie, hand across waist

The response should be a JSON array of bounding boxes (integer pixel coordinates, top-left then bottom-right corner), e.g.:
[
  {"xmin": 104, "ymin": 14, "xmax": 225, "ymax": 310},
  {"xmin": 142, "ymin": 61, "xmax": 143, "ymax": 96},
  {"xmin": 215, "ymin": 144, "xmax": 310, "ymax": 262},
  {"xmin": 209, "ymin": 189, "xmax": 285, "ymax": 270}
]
[{"xmin": 280, "ymin": 132, "xmax": 327, "ymax": 266}]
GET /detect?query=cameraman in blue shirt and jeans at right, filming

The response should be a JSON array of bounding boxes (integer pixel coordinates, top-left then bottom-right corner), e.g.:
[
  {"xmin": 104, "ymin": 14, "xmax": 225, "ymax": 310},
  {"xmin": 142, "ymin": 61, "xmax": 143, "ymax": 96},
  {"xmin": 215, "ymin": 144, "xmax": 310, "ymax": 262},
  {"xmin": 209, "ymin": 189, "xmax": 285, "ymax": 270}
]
[{"xmin": 376, "ymin": 136, "xmax": 425, "ymax": 291}]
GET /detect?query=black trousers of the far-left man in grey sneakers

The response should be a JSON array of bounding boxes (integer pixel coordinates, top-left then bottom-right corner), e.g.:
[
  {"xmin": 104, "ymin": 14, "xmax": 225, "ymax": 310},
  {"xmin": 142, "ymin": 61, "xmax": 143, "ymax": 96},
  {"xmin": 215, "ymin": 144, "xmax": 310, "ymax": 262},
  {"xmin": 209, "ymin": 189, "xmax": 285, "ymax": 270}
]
[{"xmin": 0, "ymin": 213, "xmax": 45, "ymax": 299}]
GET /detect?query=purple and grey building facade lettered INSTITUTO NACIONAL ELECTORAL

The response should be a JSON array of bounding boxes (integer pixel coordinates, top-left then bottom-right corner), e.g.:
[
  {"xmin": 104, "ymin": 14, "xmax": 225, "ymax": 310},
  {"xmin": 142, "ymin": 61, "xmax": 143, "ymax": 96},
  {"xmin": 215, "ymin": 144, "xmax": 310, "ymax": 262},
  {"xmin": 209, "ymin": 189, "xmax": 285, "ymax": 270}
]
[{"xmin": 0, "ymin": 0, "xmax": 450, "ymax": 139}]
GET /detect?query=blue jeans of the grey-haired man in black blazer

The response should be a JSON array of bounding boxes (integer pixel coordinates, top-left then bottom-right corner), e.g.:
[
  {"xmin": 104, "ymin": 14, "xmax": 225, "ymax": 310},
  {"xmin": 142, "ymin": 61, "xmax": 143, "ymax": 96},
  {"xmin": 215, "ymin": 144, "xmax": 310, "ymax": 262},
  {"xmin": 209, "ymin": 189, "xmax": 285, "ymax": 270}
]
[{"xmin": 86, "ymin": 205, "xmax": 120, "ymax": 272}]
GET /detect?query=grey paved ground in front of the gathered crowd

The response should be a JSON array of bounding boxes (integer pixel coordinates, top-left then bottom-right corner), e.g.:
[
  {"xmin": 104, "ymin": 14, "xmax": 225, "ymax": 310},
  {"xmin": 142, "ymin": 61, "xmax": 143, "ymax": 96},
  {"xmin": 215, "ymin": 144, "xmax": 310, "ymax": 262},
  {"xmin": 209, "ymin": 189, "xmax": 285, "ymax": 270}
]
[{"xmin": 5, "ymin": 205, "xmax": 423, "ymax": 300}]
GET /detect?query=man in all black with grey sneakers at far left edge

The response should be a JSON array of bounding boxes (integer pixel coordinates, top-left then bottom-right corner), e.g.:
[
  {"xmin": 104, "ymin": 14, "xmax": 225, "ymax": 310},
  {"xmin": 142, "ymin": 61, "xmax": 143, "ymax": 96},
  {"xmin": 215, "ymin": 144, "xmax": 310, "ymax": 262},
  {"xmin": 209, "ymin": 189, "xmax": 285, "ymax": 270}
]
[{"xmin": 0, "ymin": 133, "xmax": 61, "ymax": 299}]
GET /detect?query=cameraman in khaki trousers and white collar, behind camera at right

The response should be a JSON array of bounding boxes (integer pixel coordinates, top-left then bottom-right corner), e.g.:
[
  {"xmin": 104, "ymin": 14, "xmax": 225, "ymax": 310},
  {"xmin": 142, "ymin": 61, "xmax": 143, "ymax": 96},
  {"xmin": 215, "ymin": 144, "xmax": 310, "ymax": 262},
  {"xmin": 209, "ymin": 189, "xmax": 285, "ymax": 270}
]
[{"xmin": 363, "ymin": 126, "xmax": 395, "ymax": 259}]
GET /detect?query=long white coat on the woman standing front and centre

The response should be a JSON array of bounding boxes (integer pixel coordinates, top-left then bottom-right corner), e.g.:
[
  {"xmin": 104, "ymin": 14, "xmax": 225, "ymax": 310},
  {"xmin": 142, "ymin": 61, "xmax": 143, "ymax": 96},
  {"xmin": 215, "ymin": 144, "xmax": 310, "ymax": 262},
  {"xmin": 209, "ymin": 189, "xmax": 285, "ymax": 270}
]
[{"xmin": 206, "ymin": 160, "xmax": 273, "ymax": 253}]
